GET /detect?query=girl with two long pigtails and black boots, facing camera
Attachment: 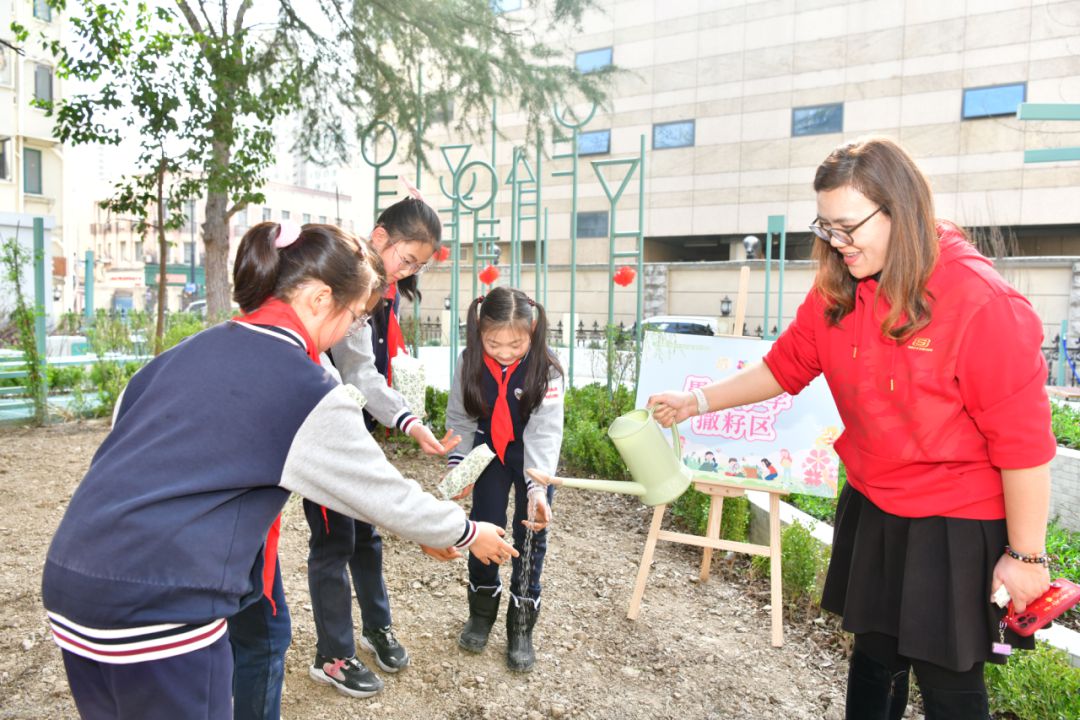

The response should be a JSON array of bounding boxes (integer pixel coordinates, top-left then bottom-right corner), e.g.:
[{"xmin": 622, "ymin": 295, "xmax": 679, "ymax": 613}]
[{"xmin": 446, "ymin": 287, "xmax": 564, "ymax": 671}]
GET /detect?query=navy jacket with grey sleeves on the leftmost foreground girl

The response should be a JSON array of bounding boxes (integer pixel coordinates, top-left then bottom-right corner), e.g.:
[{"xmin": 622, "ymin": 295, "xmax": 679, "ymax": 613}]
[{"xmin": 42, "ymin": 322, "xmax": 475, "ymax": 663}]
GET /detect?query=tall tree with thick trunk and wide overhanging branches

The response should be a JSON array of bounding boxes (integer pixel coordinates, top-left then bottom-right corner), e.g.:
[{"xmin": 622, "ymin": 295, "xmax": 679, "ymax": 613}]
[{"xmin": 15, "ymin": 0, "xmax": 607, "ymax": 313}]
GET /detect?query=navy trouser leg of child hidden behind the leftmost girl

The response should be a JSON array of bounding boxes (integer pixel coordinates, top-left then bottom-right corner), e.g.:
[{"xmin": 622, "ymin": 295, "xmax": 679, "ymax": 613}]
[{"xmin": 229, "ymin": 562, "xmax": 293, "ymax": 720}]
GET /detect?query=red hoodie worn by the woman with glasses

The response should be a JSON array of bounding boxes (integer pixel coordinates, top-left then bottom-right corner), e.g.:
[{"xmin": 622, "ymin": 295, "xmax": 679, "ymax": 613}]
[{"xmin": 765, "ymin": 223, "xmax": 1056, "ymax": 519}]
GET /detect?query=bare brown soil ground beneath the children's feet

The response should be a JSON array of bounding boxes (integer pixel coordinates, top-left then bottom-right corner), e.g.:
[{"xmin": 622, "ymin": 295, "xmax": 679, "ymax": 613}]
[{"xmin": 0, "ymin": 421, "xmax": 847, "ymax": 720}]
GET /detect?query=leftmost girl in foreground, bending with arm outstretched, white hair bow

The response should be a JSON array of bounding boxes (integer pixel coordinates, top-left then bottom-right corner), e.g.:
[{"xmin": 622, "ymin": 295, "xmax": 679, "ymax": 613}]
[{"xmin": 42, "ymin": 222, "xmax": 516, "ymax": 720}]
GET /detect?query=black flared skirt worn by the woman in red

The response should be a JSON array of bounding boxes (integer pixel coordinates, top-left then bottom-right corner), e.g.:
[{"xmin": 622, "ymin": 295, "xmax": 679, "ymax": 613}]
[{"xmin": 821, "ymin": 485, "xmax": 1035, "ymax": 673}]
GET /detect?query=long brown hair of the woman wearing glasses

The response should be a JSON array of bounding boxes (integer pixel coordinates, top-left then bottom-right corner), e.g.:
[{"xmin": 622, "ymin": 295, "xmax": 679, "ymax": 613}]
[{"xmin": 813, "ymin": 138, "xmax": 937, "ymax": 340}]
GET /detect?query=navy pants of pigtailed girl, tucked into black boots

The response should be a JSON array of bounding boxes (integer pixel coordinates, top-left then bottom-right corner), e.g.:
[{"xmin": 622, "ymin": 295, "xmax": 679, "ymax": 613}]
[{"xmin": 469, "ymin": 453, "xmax": 555, "ymax": 600}]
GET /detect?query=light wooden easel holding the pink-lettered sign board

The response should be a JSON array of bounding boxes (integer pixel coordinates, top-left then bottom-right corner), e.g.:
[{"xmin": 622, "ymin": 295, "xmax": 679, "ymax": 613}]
[{"xmin": 626, "ymin": 268, "xmax": 788, "ymax": 648}]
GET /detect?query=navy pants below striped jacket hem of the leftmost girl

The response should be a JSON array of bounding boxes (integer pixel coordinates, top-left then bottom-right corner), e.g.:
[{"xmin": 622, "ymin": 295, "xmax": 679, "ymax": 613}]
[{"xmin": 63, "ymin": 635, "xmax": 232, "ymax": 720}]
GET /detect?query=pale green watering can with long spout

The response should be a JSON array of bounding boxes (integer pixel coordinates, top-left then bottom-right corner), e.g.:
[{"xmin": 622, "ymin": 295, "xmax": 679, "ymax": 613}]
[{"xmin": 526, "ymin": 410, "xmax": 693, "ymax": 507}]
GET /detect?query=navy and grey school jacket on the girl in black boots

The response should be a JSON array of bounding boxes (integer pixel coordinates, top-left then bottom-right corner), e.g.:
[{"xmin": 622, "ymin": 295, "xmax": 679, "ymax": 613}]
[{"xmin": 446, "ymin": 355, "xmax": 565, "ymax": 492}]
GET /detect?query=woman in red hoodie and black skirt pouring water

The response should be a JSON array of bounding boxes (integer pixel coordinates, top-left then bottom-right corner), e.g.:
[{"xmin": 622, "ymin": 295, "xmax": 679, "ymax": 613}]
[{"xmin": 649, "ymin": 138, "xmax": 1055, "ymax": 720}]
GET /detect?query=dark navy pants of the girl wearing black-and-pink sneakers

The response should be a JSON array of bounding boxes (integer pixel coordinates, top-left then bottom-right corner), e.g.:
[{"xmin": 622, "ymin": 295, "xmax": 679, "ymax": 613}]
[{"xmin": 303, "ymin": 500, "xmax": 391, "ymax": 657}]
